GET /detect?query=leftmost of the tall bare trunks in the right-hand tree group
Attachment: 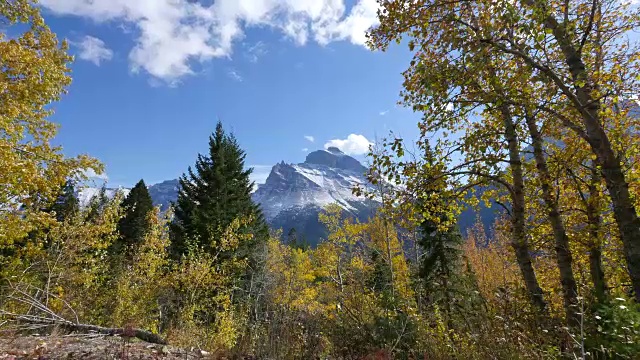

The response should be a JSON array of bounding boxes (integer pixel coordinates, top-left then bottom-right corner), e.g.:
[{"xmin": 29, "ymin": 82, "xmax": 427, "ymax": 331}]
[{"xmin": 501, "ymin": 105, "xmax": 546, "ymax": 310}]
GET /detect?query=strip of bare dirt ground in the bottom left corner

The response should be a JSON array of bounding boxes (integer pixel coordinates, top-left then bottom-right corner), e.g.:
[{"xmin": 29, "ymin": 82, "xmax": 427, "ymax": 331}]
[{"xmin": 0, "ymin": 336, "xmax": 215, "ymax": 360}]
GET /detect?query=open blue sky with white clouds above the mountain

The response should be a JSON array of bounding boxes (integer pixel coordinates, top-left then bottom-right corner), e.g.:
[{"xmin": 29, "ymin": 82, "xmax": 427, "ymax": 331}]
[{"xmin": 40, "ymin": 0, "xmax": 417, "ymax": 186}]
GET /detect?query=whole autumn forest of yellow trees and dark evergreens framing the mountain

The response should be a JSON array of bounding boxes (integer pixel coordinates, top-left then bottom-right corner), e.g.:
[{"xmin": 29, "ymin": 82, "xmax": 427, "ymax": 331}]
[{"xmin": 0, "ymin": 0, "xmax": 640, "ymax": 360}]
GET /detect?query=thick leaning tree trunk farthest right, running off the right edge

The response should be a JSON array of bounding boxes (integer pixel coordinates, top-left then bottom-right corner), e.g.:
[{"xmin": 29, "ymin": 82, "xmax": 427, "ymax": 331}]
[{"xmin": 524, "ymin": 0, "xmax": 640, "ymax": 302}]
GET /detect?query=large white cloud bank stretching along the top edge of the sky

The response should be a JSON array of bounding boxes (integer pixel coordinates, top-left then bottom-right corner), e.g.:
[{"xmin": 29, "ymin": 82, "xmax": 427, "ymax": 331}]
[{"xmin": 40, "ymin": 0, "xmax": 378, "ymax": 83}]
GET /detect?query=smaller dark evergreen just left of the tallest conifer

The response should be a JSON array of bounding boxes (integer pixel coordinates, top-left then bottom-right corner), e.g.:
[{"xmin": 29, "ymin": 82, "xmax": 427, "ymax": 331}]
[{"xmin": 115, "ymin": 180, "xmax": 153, "ymax": 251}]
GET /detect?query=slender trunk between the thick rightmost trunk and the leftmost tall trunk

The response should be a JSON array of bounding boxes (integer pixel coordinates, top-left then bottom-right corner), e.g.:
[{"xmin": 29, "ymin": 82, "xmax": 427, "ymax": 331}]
[{"xmin": 526, "ymin": 115, "xmax": 580, "ymax": 326}]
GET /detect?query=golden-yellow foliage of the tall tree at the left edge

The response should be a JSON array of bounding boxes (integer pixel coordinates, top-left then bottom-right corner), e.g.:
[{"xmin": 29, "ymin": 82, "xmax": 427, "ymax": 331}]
[{"xmin": 0, "ymin": 0, "xmax": 101, "ymax": 247}]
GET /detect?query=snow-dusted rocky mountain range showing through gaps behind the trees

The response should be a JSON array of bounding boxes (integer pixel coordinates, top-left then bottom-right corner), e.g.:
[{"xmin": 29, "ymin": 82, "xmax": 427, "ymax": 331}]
[{"xmin": 78, "ymin": 147, "xmax": 500, "ymax": 246}]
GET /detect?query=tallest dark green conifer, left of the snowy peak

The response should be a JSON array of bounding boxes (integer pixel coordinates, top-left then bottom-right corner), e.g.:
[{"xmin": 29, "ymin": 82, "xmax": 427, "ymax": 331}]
[{"xmin": 171, "ymin": 122, "xmax": 269, "ymax": 258}]
